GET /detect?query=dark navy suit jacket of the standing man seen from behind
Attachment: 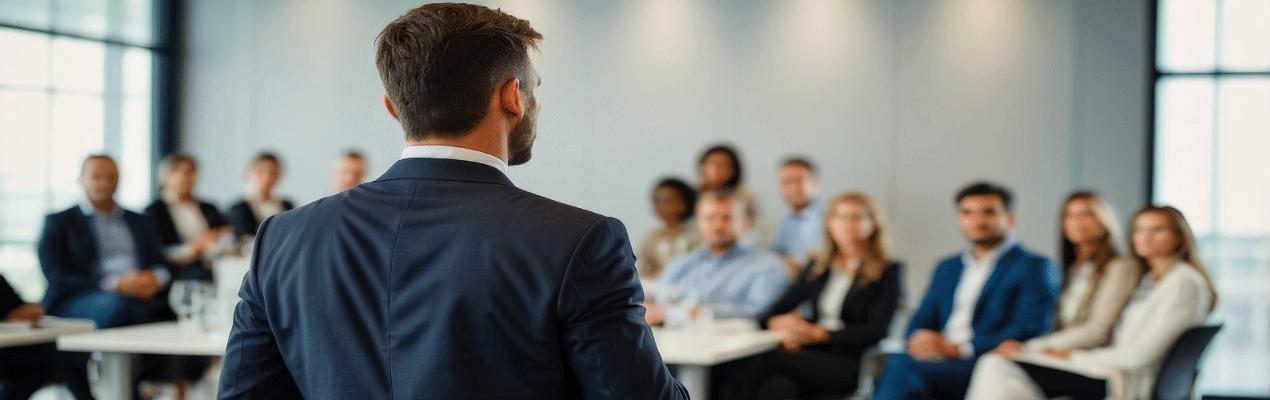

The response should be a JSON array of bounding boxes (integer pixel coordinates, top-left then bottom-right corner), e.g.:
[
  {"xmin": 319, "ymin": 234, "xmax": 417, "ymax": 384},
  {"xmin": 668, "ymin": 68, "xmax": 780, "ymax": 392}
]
[{"xmin": 220, "ymin": 159, "xmax": 687, "ymax": 399}]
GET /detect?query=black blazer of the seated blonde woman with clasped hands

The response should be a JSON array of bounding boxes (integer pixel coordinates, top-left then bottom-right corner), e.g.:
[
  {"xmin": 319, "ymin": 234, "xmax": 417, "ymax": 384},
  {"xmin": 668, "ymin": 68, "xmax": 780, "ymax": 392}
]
[{"xmin": 758, "ymin": 263, "xmax": 903, "ymax": 356}]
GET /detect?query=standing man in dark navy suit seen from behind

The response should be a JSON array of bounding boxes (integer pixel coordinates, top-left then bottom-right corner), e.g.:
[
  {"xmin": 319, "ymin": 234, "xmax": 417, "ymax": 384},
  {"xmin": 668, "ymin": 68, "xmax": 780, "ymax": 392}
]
[{"xmin": 220, "ymin": 4, "xmax": 687, "ymax": 399}]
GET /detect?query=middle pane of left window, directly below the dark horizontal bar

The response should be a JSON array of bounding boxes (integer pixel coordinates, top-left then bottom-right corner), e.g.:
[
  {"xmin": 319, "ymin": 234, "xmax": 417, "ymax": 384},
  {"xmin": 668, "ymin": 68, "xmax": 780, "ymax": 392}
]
[{"xmin": 52, "ymin": 37, "xmax": 105, "ymax": 94}]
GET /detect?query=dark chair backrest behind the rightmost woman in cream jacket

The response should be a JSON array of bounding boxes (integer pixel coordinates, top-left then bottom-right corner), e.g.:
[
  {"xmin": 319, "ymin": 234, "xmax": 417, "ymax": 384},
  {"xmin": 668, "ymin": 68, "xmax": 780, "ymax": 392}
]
[{"xmin": 1152, "ymin": 324, "xmax": 1222, "ymax": 400}]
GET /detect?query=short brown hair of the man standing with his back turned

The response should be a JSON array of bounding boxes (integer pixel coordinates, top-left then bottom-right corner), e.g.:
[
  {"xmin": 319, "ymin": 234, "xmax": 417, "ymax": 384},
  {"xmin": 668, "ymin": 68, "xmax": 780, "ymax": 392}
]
[{"xmin": 375, "ymin": 3, "xmax": 542, "ymax": 140}]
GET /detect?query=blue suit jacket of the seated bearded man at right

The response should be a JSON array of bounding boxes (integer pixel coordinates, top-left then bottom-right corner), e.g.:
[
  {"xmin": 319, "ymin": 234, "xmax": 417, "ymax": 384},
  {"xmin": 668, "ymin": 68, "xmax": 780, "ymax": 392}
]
[{"xmin": 906, "ymin": 244, "xmax": 1059, "ymax": 357}]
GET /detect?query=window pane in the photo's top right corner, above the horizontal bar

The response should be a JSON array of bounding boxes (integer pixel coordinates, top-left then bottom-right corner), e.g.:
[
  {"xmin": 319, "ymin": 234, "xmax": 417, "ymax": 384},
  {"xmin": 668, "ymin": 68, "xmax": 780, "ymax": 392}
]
[{"xmin": 1222, "ymin": 0, "xmax": 1270, "ymax": 71}]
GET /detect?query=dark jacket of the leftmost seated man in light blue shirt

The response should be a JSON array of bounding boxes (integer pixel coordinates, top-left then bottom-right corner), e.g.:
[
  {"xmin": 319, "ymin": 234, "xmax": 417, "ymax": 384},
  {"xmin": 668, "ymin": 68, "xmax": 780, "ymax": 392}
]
[{"xmin": 38, "ymin": 206, "xmax": 168, "ymax": 315}]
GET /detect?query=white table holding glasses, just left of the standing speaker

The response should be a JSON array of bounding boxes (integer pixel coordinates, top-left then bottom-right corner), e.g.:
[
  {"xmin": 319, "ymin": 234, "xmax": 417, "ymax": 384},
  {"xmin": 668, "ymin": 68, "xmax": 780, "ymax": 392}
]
[{"xmin": 57, "ymin": 321, "xmax": 229, "ymax": 399}]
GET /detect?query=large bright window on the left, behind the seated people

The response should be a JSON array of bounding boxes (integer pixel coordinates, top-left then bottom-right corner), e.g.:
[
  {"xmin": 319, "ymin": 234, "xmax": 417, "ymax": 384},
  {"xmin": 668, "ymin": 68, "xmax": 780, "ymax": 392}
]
[{"xmin": 0, "ymin": 0, "xmax": 169, "ymax": 301}]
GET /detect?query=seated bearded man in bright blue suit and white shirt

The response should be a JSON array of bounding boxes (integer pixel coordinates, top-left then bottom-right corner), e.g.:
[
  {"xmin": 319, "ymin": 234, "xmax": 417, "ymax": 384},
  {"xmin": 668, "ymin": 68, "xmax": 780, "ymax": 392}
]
[{"xmin": 874, "ymin": 183, "xmax": 1059, "ymax": 400}]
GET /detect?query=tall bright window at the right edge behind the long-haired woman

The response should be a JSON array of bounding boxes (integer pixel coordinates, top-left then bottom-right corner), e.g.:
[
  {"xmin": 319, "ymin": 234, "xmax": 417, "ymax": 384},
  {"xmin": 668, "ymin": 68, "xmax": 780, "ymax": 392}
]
[{"xmin": 1153, "ymin": 0, "xmax": 1270, "ymax": 396}]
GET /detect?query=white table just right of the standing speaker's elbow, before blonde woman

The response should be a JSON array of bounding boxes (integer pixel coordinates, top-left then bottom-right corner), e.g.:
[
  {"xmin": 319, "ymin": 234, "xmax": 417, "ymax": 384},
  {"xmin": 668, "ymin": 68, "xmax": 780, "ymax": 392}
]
[{"xmin": 653, "ymin": 328, "xmax": 781, "ymax": 399}]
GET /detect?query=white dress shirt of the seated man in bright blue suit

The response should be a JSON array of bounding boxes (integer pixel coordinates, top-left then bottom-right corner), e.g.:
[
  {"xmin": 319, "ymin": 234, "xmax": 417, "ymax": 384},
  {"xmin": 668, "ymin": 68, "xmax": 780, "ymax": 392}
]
[{"xmin": 944, "ymin": 234, "xmax": 1019, "ymax": 359}]
